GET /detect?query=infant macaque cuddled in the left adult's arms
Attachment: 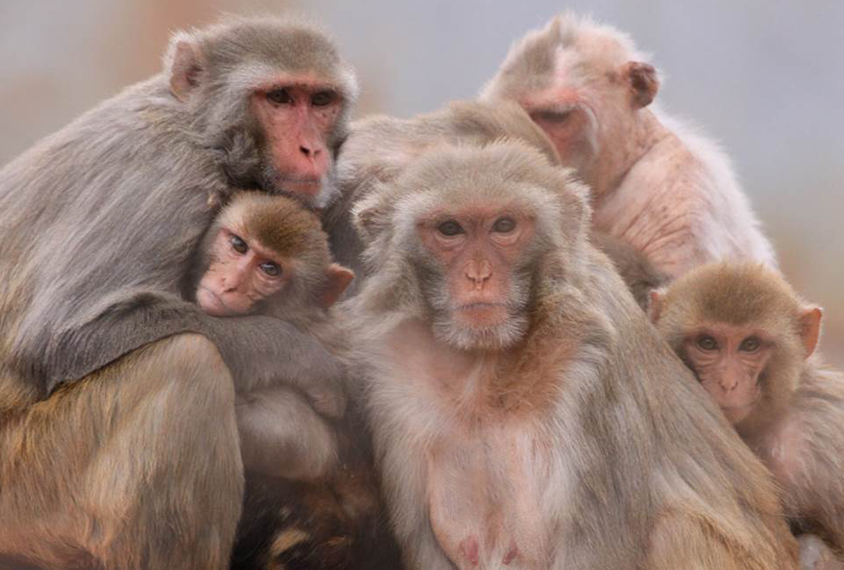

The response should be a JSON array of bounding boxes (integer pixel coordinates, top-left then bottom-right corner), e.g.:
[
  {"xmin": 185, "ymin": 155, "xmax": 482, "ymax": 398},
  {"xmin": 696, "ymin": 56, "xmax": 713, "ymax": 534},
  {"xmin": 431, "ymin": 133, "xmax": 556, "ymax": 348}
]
[{"xmin": 196, "ymin": 192, "xmax": 354, "ymax": 480}]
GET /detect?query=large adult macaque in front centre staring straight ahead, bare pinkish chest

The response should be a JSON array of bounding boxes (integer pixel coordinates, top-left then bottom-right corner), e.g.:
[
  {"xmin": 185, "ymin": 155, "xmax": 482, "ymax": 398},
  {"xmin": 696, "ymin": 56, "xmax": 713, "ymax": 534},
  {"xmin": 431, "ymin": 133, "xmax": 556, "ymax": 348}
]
[{"xmin": 346, "ymin": 142, "xmax": 796, "ymax": 570}]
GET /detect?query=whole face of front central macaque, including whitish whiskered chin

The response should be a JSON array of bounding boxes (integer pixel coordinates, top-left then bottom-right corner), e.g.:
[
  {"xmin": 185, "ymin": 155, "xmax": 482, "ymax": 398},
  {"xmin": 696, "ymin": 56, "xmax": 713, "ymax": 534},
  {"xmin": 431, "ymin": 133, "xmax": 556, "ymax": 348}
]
[{"xmin": 416, "ymin": 205, "xmax": 534, "ymax": 350}]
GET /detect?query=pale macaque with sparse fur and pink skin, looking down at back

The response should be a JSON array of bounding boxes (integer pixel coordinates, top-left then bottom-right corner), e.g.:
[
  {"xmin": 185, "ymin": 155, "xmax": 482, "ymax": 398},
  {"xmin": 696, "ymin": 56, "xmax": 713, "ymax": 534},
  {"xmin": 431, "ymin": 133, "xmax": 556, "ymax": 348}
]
[{"xmin": 481, "ymin": 14, "xmax": 776, "ymax": 277}]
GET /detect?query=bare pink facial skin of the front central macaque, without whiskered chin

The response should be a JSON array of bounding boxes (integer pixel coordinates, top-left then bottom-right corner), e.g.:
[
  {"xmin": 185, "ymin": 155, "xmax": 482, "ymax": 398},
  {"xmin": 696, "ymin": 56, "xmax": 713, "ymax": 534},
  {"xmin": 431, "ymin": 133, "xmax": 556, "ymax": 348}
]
[{"xmin": 417, "ymin": 207, "xmax": 534, "ymax": 329}]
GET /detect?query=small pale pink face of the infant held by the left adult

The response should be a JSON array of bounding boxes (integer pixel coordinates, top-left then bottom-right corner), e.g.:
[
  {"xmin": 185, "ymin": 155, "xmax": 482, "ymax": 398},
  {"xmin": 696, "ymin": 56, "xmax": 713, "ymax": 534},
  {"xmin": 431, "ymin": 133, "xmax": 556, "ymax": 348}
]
[{"xmin": 196, "ymin": 228, "xmax": 292, "ymax": 317}]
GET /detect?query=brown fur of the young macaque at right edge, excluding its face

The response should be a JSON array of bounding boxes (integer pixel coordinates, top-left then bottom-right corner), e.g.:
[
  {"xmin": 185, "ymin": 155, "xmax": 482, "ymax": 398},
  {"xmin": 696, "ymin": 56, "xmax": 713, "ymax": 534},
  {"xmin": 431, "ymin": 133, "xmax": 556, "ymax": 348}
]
[{"xmin": 657, "ymin": 264, "xmax": 844, "ymax": 556}]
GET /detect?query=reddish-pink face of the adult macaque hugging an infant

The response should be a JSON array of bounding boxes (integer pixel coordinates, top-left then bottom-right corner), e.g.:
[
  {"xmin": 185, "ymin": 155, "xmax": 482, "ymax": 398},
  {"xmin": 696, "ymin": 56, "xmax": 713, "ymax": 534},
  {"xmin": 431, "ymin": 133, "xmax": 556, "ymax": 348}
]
[{"xmin": 252, "ymin": 76, "xmax": 345, "ymax": 205}]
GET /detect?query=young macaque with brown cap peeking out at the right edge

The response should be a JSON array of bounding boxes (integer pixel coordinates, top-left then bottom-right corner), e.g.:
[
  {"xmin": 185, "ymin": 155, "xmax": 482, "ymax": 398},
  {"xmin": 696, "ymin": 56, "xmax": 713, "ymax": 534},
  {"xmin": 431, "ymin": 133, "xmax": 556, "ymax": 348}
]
[{"xmin": 650, "ymin": 264, "xmax": 844, "ymax": 554}]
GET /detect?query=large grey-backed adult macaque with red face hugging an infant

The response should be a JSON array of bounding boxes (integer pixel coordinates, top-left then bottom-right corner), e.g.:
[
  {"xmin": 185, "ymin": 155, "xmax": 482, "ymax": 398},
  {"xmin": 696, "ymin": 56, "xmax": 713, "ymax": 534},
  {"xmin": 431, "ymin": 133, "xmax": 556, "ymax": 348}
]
[{"xmin": 0, "ymin": 18, "xmax": 356, "ymax": 569}]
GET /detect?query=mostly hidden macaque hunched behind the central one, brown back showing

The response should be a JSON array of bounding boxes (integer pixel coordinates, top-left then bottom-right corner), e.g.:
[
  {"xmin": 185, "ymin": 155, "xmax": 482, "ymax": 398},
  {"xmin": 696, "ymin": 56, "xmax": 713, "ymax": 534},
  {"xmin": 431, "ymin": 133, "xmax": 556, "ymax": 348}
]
[{"xmin": 324, "ymin": 97, "xmax": 666, "ymax": 307}]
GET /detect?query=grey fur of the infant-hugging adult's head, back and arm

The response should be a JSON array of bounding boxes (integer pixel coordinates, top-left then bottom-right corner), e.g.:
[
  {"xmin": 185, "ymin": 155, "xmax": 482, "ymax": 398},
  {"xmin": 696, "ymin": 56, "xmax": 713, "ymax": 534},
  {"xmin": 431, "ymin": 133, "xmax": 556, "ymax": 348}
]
[{"xmin": 0, "ymin": 19, "xmax": 356, "ymax": 411}]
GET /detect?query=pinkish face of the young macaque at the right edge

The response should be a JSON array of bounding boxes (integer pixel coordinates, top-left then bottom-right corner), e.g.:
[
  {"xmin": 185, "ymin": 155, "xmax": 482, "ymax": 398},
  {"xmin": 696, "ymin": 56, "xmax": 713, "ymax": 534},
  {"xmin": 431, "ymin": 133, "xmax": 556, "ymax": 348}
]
[{"xmin": 682, "ymin": 324, "xmax": 775, "ymax": 424}]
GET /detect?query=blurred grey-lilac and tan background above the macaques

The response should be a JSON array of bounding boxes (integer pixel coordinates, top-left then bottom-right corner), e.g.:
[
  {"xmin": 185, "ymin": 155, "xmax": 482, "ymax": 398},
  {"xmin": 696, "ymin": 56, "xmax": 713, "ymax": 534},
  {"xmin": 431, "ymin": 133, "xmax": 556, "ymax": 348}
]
[{"xmin": 0, "ymin": 0, "xmax": 844, "ymax": 366}]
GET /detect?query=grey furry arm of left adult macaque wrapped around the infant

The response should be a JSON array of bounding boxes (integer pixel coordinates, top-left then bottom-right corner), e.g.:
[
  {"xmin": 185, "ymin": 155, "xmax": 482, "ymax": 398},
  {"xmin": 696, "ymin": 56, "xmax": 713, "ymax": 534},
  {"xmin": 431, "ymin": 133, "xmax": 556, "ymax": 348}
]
[{"xmin": 10, "ymin": 290, "xmax": 345, "ymax": 415}]
